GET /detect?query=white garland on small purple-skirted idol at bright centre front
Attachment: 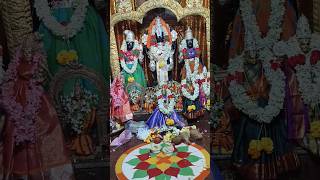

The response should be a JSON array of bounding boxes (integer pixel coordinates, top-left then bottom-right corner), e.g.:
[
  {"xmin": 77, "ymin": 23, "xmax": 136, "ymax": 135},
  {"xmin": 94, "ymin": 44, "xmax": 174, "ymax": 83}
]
[{"xmin": 156, "ymin": 89, "xmax": 176, "ymax": 115}]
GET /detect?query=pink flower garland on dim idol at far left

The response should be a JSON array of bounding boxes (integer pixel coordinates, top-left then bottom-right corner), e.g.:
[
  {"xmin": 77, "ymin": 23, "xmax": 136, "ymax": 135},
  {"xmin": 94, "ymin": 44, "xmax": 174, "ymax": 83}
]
[{"xmin": 1, "ymin": 49, "xmax": 45, "ymax": 145}]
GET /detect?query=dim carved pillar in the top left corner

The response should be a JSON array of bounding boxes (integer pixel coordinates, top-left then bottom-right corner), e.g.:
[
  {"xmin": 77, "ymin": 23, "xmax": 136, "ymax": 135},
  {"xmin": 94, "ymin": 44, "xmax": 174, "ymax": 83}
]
[{"xmin": 0, "ymin": 0, "xmax": 33, "ymax": 57}]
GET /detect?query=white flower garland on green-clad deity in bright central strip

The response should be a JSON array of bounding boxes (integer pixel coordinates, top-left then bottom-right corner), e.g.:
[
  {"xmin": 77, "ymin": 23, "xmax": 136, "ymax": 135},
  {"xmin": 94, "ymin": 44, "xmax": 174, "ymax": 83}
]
[{"xmin": 120, "ymin": 40, "xmax": 143, "ymax": 74}]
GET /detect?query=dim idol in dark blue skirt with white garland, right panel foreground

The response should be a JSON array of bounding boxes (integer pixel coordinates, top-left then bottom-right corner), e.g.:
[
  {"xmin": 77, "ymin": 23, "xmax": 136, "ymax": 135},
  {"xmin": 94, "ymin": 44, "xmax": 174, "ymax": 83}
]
[{"xmin": 225, "ymin": 30, "xmax": 299, "ymax": 179}]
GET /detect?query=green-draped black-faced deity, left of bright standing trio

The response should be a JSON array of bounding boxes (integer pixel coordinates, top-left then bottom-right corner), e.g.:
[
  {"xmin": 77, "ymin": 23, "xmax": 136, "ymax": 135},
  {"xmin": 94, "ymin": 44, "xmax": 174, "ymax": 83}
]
[{"xmin": 119, "ymin": 30, "xmax": 147, "ymax": 90}]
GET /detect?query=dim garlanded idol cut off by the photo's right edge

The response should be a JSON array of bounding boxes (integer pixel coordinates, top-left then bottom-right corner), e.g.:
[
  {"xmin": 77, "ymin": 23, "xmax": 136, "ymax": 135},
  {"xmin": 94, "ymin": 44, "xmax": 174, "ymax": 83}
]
[{"xmin": 274, "ymin": 15, "xmax": 320, "ymax": 155}]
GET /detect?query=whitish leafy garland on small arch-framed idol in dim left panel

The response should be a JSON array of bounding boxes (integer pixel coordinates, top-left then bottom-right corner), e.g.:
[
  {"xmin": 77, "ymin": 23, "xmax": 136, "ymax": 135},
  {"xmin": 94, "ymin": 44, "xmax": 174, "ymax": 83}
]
[{"xmin": 61, "ymin": 90, "xmax": 98, "ymax": 134}]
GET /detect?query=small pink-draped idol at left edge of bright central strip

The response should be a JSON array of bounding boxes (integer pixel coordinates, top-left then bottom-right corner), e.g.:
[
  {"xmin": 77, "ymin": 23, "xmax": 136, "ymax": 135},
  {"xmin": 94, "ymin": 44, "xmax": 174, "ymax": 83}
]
[{"xmin": 110, "ymin": 76, "xmax": 133, "ymax": 124}]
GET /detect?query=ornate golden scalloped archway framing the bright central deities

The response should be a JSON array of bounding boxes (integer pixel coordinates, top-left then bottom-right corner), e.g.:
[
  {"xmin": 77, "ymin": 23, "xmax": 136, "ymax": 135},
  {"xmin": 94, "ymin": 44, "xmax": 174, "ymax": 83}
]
[{"xmin": 110, "ymin": 0, "xmax": 210, "ymax": 76}]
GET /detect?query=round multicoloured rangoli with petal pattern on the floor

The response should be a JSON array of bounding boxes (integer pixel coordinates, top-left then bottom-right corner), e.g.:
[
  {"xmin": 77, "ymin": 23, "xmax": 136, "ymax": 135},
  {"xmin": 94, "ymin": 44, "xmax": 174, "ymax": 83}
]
[{"xmin": 116, "ymin": 144, "xmax": 210, "ymax": 180}]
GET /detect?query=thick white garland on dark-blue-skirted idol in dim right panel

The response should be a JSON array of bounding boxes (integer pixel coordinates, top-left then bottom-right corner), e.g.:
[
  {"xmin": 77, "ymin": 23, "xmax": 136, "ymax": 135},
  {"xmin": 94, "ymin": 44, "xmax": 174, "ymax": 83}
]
[{"xmin": 228, "ymin": 49, "xmax": 285, "ymax": 123}]
